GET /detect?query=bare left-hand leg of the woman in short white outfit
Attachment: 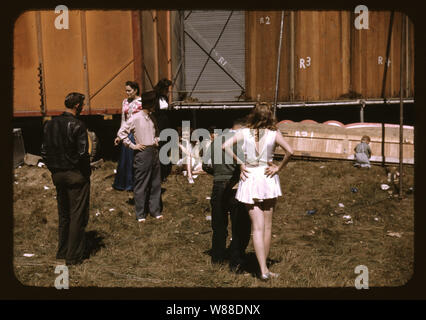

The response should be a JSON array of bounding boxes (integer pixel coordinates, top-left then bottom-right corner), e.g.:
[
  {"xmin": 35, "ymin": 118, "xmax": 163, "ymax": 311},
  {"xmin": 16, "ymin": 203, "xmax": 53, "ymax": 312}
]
[{"xmin": 247, "ymin": 205, "xmax": 269, "ymax": 274}]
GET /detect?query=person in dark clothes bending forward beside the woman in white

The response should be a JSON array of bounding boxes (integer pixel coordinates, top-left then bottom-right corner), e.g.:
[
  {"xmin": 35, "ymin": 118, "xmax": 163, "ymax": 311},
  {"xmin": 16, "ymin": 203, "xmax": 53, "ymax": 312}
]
[{"xmin": 203, "ymin": 119, "xmax": 251, "ymax": 273}]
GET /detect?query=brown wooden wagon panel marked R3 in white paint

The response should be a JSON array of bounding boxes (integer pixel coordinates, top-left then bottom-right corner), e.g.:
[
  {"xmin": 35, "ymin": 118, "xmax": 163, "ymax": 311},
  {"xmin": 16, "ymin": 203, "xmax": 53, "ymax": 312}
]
[{"xmin": 295, "ymin": 11, "xmax": 350, "ymax": 101}]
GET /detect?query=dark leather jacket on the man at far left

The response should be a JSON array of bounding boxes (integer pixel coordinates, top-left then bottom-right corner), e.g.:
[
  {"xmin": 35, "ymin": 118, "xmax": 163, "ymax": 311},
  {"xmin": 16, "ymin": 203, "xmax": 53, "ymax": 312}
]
[{"xmin": 41, "ymin": 112, "xmax": 91, "ymax": 177}]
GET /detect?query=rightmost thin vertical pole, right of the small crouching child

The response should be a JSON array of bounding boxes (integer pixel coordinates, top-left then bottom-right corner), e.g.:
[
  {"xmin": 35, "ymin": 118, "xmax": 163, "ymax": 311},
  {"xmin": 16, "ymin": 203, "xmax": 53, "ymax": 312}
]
[{"xmin": 399, "ymin": 13, "xmax": 405, "ymax": 199}]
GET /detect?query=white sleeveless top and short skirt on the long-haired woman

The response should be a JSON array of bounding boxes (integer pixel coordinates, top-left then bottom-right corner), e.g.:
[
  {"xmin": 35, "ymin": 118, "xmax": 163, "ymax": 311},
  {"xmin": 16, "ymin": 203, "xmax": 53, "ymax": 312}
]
[{"xmin": 235, "ymin": 128, "xmax": 282, "ymax": 204}]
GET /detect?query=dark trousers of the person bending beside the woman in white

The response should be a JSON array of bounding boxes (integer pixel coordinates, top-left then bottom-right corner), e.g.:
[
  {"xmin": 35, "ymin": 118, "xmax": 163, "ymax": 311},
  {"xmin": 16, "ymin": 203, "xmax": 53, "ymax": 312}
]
[{"xmin": 210, "ymin": 181, "xmax": 251, "ymax": 265}]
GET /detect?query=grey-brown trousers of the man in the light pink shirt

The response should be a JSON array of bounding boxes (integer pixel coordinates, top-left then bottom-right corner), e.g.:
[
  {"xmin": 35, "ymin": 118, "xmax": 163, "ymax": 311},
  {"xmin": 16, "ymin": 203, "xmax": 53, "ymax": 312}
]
[{"xmin": 133, "ymin": 146, "xmax": 162, "ymax": 219}]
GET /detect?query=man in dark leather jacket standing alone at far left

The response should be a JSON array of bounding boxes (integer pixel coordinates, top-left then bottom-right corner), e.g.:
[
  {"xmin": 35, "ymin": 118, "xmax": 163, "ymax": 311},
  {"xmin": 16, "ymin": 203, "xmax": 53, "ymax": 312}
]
[{"xmin": 41, "ymin": 92, "xmax": 91, "ymax": 265}]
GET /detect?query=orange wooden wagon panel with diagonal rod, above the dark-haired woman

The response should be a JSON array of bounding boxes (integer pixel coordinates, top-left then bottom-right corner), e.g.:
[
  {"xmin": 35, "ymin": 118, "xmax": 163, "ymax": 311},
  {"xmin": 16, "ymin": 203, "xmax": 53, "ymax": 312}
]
[{"xmin": 86, "ymin": 10, "xmax": 135, "ymax": 109}]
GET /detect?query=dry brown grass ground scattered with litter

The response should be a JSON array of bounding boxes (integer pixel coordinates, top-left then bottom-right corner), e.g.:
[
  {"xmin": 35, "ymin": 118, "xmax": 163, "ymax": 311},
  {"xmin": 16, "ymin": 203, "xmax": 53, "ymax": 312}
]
[{"xmin": 13, "ymin": 160, "xmax": 414, "ymax": 288}]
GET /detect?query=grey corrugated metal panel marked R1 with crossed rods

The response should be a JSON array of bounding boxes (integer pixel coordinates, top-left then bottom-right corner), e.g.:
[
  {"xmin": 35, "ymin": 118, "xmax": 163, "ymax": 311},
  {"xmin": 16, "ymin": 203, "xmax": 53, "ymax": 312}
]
[{"xmin": 185, "ymin": 11, "xmax": 245, "ymax": 101}]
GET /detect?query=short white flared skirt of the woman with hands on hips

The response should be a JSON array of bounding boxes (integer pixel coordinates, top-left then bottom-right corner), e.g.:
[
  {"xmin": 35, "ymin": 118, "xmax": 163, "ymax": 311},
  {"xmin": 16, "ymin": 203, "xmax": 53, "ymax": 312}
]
[{"xmin": 235, "ymin": 166, "xmax": 282, "ymax": 204}]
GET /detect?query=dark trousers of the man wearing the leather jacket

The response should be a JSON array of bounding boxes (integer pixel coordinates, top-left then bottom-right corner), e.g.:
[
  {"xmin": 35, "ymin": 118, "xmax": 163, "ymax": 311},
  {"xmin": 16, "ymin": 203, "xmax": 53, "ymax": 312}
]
[{"xmin": 52, "ymin": 170, "xmax": 90, "ymax": 263}]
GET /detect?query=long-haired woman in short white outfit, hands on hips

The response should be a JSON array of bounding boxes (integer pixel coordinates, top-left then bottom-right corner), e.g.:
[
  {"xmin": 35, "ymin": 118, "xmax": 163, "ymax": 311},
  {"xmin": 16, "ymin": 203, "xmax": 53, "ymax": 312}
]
[{"xmin": 222, "ymin": 103, "xmax": 293, "ymax": 280}]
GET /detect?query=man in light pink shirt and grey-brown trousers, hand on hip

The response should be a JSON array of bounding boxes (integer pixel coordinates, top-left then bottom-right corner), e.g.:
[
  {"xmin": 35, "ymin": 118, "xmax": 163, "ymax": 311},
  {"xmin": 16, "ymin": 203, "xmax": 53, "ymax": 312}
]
[{"xmin": 117, "ymin": 91, "xmax": 163, "ymax": 222}]
